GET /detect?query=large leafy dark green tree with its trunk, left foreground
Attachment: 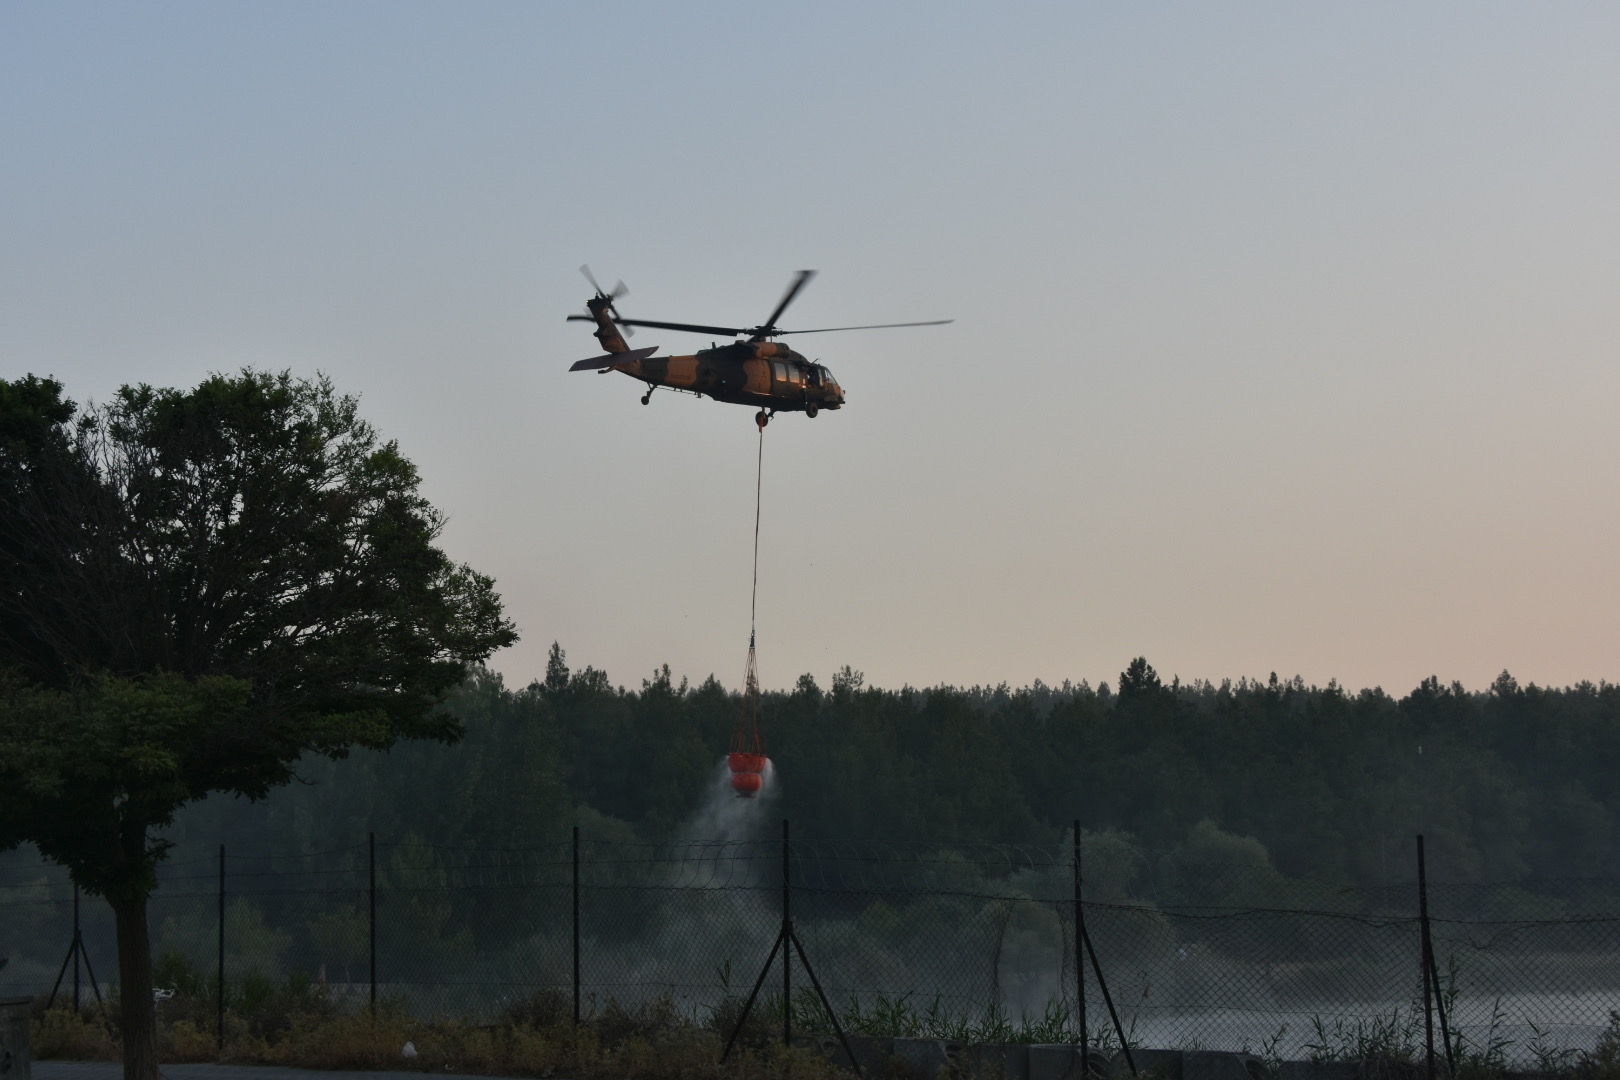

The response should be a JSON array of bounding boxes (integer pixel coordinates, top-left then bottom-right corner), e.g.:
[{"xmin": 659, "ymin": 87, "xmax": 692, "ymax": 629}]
[{"xmin": 0, "ymin": 371, "xmax": 515, "ymax": 1080}]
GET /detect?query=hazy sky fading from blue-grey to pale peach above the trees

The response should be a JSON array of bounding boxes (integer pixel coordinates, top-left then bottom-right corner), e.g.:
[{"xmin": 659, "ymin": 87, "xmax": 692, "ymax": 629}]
[{"xmin": 0, "ymin": 0, "xmax": 1620, "ymax": 693}]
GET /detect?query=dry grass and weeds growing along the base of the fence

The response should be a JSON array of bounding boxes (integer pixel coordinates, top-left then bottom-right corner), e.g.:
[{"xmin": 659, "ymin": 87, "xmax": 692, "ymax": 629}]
[{"xmin": 32, "ymin": 957, "xmax": 1620, "ymax": 1080}]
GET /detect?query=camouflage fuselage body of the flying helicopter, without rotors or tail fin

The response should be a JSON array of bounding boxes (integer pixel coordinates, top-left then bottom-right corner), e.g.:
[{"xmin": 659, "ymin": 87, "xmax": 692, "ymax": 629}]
[{"xmin": 603, "ymin": 342, "xmax": 844, "ymax": 416}]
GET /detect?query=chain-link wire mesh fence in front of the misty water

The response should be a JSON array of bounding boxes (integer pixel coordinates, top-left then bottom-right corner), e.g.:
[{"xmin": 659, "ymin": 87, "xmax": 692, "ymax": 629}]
[{"xmin": 0, "ymin": 834, "xmax": 1620, "ymax": 1062}]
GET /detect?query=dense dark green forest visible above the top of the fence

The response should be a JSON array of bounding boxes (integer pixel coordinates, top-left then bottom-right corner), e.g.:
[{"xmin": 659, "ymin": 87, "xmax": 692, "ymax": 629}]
[{"xmin": 154, "ymin": 646, "xmax": 1620, "ymax": 884}]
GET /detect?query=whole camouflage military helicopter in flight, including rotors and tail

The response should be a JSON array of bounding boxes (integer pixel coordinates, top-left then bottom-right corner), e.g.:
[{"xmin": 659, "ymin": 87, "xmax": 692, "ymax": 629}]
[{"xmin": 569, "ymin": 266, "xmax": 953, "ymax": 431}]
